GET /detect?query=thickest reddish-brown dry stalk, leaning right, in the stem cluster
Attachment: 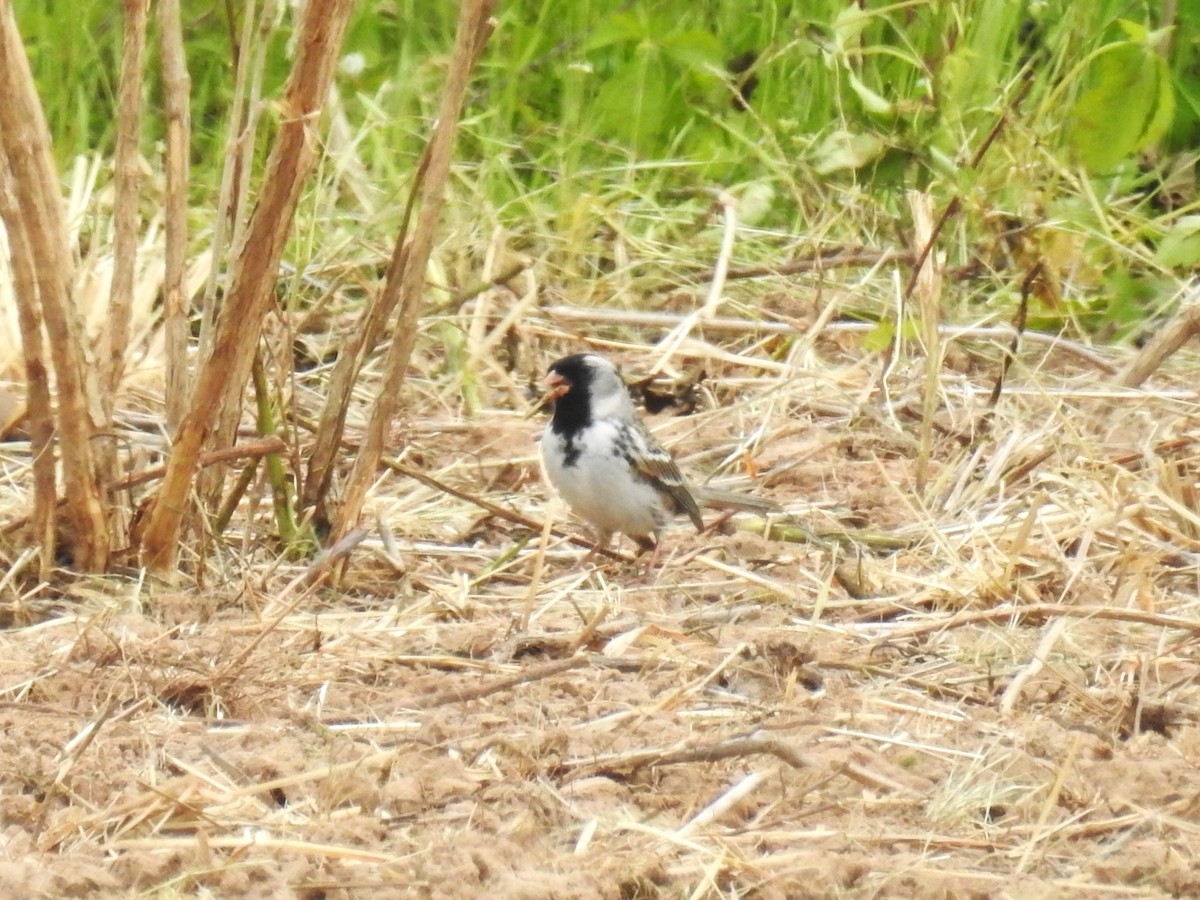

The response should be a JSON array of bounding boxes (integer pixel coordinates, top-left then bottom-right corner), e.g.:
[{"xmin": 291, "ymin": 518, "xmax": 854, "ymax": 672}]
[{"xmin": 142, "ymin": 0, "xmax": 354, "ymax": 574}]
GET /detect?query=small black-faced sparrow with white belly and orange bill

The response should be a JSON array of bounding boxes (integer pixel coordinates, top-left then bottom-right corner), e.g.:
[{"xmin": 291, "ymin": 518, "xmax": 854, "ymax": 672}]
[{"xmin": 541, "ymin": 353, "xmax": 779, "ymax": 569}]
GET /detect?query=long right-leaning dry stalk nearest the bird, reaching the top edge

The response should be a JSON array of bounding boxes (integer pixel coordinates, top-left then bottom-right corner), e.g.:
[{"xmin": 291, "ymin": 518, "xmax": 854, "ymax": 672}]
[{"xmin": 334, "ymin": 0, "xmax": 496, "ymax": 541}]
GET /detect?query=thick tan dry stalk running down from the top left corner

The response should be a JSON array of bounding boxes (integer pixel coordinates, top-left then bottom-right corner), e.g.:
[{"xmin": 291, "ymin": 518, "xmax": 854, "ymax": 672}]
[{"xmin": 0, "ymin": 4, "xmax": 109, "ymax": 571}]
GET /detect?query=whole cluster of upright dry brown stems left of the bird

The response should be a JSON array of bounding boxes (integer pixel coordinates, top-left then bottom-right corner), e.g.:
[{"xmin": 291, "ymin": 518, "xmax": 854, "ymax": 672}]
[{"xmin": 0, "ymin": 0, "xmax": 494, "ymax": 577}]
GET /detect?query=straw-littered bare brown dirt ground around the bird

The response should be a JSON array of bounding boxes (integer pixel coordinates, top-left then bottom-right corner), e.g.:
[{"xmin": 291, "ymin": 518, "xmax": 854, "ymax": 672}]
[{"xmin": 0, "ymin": 319, "xmax": 1200, "ymax": 900}]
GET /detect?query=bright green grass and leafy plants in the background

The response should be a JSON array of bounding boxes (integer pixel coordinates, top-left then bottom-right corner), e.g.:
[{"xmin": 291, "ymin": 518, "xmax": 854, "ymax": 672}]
[{"xmin": 16, "ymin": 0, "xmax": 1200, "ymax": 336}]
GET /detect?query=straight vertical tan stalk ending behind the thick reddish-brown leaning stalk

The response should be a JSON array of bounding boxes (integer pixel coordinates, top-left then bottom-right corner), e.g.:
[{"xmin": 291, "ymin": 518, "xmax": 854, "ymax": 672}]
[{"xmin": 158, "ymin": 0, "xmax": 191, "ymax": 434}]
